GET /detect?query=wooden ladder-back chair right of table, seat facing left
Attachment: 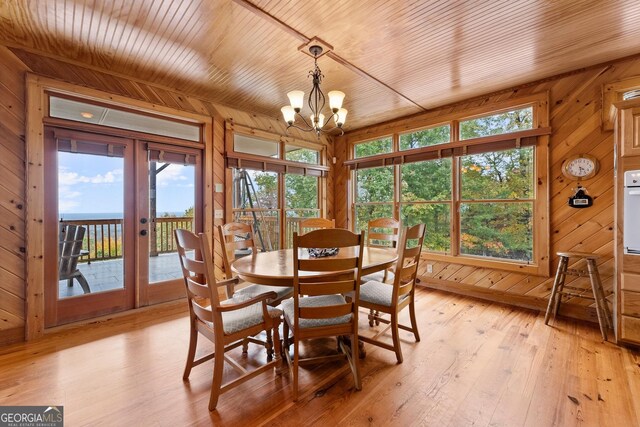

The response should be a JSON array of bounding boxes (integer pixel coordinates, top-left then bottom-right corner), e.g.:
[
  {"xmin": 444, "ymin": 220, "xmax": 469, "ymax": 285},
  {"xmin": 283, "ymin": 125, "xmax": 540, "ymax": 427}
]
[{"xmin": 360, "ymin": 224, "xmax": 425, "ymax": 363}]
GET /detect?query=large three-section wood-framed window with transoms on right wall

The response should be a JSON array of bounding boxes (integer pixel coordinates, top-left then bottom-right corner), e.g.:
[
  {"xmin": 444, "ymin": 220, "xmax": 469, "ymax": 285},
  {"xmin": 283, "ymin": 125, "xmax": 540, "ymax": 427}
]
[{"xmin": 345, "ymin": 95, "xmax": 550, "ymax": 275}]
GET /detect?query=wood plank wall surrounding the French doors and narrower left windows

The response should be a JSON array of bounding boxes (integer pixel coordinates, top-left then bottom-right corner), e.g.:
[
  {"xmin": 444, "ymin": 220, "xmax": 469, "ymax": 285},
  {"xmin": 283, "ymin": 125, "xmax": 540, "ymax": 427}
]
[{"xmin": 0, "ymin": 46, "xmax": 333, "ymax": 345}]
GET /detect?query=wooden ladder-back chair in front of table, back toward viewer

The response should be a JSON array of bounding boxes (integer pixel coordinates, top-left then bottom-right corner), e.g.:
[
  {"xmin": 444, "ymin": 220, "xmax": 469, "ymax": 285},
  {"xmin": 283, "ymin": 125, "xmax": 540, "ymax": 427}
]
[{"xmin": 282, "ymin": 229, "xmax": 364, "ymax": 401}]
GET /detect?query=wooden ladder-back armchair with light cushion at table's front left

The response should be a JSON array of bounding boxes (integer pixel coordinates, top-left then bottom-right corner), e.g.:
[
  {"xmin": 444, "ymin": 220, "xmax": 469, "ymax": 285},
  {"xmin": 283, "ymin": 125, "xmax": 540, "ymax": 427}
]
[{"xmin": 175, "ymin": 229, "xmax": 282, "ymax": 411}]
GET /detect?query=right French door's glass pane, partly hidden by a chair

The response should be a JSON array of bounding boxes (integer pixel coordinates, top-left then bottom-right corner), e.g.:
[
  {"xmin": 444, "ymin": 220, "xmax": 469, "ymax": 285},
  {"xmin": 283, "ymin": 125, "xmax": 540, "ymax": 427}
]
[{"xmin": 148, "ymin": 161, "xmax": 196, "ymax": 284}]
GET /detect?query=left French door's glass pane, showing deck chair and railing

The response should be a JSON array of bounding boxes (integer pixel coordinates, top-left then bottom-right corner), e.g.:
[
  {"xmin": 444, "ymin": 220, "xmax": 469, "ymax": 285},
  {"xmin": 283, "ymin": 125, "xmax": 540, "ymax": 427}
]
[{"xmin": 58, "ymin": 152, "xmax": 124, "ymax": 299}]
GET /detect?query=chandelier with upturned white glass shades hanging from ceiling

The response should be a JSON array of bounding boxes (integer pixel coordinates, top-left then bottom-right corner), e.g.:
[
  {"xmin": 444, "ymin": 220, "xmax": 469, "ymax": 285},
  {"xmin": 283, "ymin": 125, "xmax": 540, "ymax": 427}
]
[{"xmin": 281, "ymin": 45, "xmax": 347, "ymax": 136}]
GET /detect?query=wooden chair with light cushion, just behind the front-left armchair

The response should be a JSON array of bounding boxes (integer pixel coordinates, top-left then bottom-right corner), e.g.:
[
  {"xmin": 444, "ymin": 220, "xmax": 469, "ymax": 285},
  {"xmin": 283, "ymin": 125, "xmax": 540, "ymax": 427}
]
[{"xmin": 218, "ymin": 222, "xmax": 293, "ymax": 307}]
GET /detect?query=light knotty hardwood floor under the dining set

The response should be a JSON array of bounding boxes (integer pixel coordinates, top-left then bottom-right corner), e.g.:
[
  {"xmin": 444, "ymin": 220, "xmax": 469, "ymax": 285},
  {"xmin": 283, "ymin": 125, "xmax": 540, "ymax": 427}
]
[{"xmin": 0, "ymin": 289, "xmax": 640, "ymax": 427}]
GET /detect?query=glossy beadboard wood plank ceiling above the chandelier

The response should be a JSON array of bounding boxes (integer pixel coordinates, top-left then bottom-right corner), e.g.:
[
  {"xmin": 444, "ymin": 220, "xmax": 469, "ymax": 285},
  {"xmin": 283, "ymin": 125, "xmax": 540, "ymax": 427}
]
[{"xmin": 0, "ymin": 0, "xmax": 640, "ymax": 129}]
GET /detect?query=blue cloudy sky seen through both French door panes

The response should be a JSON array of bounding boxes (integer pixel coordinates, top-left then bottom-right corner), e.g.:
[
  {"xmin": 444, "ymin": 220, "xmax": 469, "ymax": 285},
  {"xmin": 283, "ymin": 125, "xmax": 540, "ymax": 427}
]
[{"xmin": 58, "ymin": 152, "xmax": 194, "ymax": 214}]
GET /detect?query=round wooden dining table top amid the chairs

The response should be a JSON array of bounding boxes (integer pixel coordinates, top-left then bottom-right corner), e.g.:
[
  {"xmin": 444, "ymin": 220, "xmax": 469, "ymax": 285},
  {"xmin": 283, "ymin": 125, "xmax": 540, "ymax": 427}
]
[{"xmin": 231, "ymin": 247, "xmax": 398, "ymax": 286}]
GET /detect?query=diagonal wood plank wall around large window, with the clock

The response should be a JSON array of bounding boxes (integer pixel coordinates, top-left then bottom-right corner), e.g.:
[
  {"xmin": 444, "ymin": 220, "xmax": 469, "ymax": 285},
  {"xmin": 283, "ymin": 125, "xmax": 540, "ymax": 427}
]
[{"xmin": 335, "ymin": 58, "xmax": 640, "ymax": 320}]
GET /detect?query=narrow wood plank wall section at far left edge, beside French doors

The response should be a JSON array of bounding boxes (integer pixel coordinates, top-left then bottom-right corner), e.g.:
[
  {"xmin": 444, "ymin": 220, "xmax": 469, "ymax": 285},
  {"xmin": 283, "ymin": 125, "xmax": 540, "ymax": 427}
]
[{"xmin": 0, "ymin": 46, "xmax": 28, "ymax": 345}]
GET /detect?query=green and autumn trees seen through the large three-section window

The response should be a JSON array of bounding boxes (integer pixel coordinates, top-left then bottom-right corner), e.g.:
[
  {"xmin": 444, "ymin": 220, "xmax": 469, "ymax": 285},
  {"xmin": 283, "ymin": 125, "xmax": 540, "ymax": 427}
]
[{"xmin": 355, "ymin": 108, "xmax": 534, "ymax": 261}]
